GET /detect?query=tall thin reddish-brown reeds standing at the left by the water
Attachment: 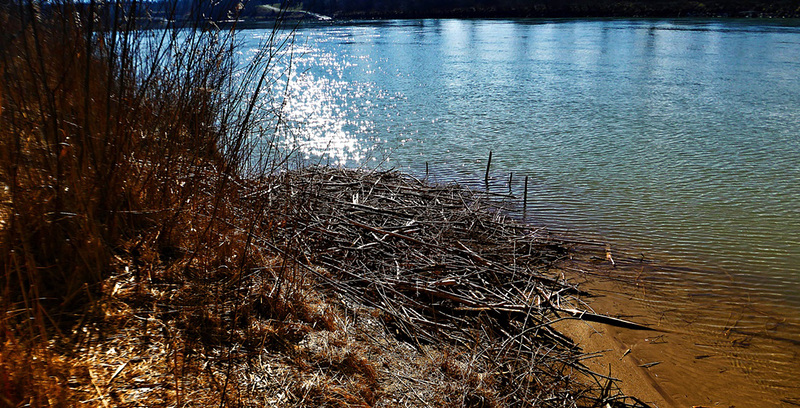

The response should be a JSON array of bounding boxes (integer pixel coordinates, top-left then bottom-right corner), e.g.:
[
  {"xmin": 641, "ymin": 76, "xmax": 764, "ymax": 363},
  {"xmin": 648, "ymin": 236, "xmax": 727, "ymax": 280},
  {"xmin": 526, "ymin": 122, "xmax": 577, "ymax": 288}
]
[{"xmin": 0, "ymin": 0, "xmax": 291, "ymax": 405}]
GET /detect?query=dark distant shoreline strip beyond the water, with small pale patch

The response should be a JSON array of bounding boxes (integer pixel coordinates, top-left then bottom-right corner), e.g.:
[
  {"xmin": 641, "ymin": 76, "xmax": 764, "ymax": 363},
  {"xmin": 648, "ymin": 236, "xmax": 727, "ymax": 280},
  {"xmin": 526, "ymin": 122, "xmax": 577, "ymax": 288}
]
[{"xmin": 40, "ymin": 0, "xmax": 800, "ymax": 28}]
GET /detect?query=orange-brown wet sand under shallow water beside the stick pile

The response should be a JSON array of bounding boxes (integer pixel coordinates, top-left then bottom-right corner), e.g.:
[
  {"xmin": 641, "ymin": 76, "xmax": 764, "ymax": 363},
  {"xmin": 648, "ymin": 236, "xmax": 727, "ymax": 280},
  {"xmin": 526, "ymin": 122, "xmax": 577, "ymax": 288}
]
[{"xmin": 557, "ymin": 250, "xmax": 800, "ymax": 408}]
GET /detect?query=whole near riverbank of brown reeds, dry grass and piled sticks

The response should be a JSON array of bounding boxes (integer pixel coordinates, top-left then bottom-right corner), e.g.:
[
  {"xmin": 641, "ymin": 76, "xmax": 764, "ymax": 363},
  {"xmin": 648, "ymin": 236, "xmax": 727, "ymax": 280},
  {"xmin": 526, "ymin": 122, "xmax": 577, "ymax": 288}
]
[{"xmin": 0, "ymin": 1, "xmax": 645, "ymax": 407}]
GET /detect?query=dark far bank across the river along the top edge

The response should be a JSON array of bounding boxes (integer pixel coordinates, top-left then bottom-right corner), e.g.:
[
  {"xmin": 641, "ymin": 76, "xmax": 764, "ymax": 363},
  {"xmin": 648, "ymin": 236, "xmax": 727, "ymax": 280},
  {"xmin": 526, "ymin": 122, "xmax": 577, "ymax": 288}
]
[{"xmin": 54, "ymin": 0, "xmax": 800, "ymax": 21}]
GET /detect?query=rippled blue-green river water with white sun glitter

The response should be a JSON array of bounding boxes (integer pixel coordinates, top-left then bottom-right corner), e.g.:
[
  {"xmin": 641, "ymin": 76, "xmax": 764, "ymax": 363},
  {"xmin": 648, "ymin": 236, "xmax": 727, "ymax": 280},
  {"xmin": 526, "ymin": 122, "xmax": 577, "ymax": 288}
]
[{"xmin": 242, "ymin": 20, "xmax": 800, "ymax": 404}]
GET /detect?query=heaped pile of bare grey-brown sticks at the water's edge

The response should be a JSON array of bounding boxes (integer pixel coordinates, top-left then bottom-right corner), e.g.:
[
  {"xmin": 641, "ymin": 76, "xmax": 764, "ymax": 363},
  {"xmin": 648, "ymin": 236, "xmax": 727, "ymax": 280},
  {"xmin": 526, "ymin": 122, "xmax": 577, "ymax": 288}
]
[{"xmin": 261, "ymin": 167, "xmax": 642, "ymax": 406}]
